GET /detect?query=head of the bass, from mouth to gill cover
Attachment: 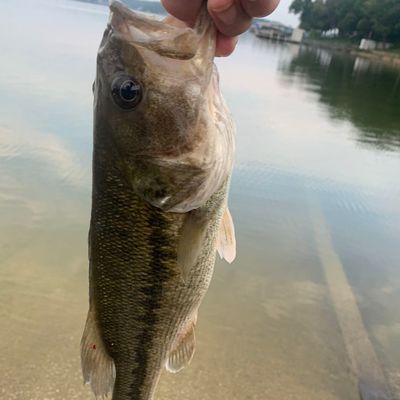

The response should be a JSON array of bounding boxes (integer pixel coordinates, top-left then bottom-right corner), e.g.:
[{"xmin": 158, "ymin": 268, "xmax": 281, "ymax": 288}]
[{"xmin": 94, "ymin": 1, "xmax": 233, "ymax": 212}]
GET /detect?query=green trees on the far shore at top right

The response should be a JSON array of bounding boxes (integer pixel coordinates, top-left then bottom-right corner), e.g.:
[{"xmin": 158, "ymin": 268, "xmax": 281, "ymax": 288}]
[{"xmin": 289, "ymin": 0, "xmax": 400, "ymax": 42}]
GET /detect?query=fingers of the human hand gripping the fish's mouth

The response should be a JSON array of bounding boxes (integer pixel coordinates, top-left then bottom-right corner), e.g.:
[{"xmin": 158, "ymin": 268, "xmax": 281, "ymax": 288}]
[{"xmin": 161, "ymin": 0, "xmax": 280, "ymax": 56}]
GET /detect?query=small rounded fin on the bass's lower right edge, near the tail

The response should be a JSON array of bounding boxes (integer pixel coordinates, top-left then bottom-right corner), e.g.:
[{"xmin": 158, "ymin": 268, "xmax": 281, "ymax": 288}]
[{"xmin": 166, "ymin": 320, "xmax": 196, "ymax": 373}]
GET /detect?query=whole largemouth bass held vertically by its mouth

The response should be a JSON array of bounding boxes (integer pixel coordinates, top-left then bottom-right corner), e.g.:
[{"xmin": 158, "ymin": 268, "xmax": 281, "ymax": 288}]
[{"xmin": 81, "ymin": 1, "xmax": 235, "ymax": 400}]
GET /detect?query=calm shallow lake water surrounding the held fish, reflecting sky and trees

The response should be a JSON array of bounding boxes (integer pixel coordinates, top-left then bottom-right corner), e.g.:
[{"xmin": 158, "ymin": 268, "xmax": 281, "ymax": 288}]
[{"xmin": 0, "ymin": 0, "xmax": 400, "ymax": 400}]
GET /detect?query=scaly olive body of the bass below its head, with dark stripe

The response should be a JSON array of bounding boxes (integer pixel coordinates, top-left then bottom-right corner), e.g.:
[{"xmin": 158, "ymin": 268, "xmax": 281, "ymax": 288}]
[{"xmin": 90, "ymin": 164, "xmax": 226, "ymax": 400}]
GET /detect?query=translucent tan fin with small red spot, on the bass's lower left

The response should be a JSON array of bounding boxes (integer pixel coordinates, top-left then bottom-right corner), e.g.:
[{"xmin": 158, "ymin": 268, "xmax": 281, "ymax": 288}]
[{"xmin": 81, "ymin": 307, "xmax": 115, "ymax": 398}]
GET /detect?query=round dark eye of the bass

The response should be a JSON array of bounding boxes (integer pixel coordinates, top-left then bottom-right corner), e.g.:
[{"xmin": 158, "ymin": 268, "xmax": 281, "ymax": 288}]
[{"xmin": 111, "ymin": 75, "xmax": 142, "ymax": 110}]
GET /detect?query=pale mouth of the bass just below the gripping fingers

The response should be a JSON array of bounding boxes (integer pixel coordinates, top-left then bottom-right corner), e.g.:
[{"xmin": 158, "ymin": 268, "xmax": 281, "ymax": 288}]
[{"xmin": 109, "ymin": 0, "xmax": 201, "ymax": 60}]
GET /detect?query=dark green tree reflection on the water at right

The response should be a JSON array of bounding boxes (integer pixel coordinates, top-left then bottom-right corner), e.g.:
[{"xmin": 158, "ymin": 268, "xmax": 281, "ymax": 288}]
[{"xmin": 282, "ymin": 48, "xmax": 400, "ymax": 149}]
